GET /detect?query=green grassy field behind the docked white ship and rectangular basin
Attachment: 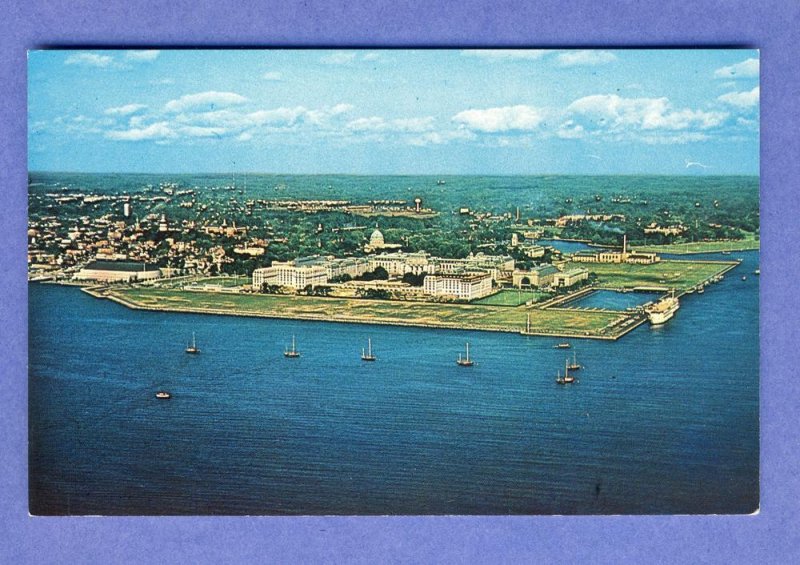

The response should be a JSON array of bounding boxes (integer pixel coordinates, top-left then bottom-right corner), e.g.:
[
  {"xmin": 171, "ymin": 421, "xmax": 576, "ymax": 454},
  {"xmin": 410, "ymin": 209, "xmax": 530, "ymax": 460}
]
[{"xmin": 586, "ymin": 261, "xmax": 731, "ymax": 290}]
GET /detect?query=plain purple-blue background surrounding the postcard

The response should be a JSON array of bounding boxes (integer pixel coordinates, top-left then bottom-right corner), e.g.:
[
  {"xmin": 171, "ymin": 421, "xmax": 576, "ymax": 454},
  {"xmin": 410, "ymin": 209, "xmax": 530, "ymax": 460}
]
[{"xmin": 0, "ymin": 0, "xmax": 800, "ymax": 563}]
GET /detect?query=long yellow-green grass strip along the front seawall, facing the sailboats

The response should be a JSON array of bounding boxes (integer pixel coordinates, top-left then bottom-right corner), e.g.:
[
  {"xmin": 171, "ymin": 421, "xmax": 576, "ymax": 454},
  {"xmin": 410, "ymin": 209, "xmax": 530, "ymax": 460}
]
[{"xmin": 113, "ymin": 288, "xmax": 624, "ymax": 336}]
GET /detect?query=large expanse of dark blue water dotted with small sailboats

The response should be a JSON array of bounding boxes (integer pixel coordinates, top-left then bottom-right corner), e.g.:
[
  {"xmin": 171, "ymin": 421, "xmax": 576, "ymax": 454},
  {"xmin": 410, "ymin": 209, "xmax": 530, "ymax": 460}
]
[{"xmin": 29, "ymin": 252, "xmax": 758, "ymax": 514}]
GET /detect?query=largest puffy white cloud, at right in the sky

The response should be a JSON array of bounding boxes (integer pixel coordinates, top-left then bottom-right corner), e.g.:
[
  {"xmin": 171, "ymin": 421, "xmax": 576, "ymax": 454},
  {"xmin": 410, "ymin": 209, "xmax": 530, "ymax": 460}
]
[{"xmin": 567, "ymin": 94, "xmax": 728, "ymax": 131}]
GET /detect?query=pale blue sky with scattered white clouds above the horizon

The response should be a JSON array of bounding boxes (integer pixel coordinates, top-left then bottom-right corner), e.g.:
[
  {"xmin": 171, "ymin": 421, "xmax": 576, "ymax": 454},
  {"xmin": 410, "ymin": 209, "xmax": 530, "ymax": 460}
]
[{"xmin": 28, "ymin": 49, "xmax": 759, "ymax": 175}]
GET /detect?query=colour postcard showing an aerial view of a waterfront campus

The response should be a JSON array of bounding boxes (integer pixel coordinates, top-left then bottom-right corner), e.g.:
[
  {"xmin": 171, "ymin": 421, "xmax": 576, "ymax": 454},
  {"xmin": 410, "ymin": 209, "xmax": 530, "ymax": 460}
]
[{"xmin": 27, "ymin": 49, "xmax": 760, "ymax": 515}]
